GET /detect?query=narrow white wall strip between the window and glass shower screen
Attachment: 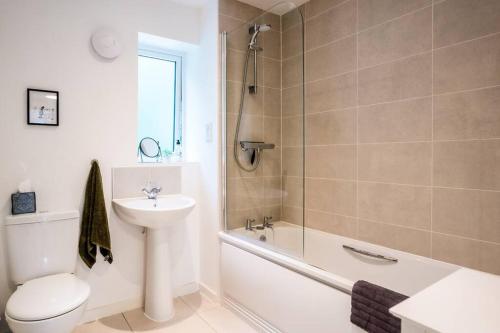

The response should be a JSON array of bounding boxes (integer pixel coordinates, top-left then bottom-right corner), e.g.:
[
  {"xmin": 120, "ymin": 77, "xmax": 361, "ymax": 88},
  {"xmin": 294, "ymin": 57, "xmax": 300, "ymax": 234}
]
[{"xmin": 185, "ymin": 0, "xmax": 221, "ymax": 295}]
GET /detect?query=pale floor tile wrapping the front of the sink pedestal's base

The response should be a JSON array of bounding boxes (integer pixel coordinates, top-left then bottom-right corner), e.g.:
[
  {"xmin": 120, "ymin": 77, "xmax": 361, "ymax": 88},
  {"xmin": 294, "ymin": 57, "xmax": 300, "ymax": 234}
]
[{"xmin": 124, "ymin": 299, "xmax": 214, "ymax": 333}]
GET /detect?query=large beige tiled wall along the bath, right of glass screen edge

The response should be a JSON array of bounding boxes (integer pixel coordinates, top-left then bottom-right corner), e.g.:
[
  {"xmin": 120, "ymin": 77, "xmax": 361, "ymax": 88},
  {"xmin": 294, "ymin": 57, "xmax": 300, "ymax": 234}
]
[{"xmin": 283, "ymin": 0, "xmax": 500, "ymax": 274}]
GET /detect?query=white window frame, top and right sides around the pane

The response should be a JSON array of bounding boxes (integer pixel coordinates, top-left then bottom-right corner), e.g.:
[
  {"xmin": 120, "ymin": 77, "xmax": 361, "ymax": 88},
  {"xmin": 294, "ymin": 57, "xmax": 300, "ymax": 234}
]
[{"xmin": 137, "ymin": 47, "xmax": 184, "ymax": 153}]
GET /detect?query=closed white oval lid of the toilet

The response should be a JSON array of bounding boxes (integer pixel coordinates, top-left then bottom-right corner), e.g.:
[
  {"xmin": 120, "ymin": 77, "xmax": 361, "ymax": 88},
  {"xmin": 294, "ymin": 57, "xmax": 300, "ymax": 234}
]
[{"xmin": 5, "ymin": 273, "xmax": 90, "ymax": 321}]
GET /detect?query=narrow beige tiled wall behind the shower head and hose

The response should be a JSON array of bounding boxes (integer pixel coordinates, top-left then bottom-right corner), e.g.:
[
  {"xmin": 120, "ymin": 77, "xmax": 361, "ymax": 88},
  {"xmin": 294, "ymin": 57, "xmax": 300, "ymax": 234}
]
[{"xmin": 219, "ymin": 0, "xmax": 282, "ymax": 229}]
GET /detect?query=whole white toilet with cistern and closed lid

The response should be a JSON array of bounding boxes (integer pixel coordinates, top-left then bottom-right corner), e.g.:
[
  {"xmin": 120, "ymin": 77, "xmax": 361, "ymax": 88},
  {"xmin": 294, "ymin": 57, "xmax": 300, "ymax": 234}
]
[{"xmin": 5, "ymin": 211, "xmax": 90, "ymax": 333}]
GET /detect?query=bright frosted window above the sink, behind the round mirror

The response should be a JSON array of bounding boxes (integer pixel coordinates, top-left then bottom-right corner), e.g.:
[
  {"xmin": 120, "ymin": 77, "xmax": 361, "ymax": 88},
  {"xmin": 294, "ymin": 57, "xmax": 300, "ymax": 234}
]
[{"xmin": 137, "ymin": 50, "xmax": 182, "ymax": 156}]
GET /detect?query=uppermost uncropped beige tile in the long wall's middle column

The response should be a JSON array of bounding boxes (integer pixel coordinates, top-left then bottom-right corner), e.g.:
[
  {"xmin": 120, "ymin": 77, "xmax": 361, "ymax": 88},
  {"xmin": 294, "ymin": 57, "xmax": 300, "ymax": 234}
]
[{"xmin": 358, "ymin": 7, "xmax": 432, "ymax": 68}]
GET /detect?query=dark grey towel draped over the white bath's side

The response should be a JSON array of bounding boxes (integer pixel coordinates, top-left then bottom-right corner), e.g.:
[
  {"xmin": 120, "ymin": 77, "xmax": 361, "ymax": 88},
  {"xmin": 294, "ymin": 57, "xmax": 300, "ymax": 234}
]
[{"xmin": 351, "ymin": 280, "xmax": 408, "ymax": 333}]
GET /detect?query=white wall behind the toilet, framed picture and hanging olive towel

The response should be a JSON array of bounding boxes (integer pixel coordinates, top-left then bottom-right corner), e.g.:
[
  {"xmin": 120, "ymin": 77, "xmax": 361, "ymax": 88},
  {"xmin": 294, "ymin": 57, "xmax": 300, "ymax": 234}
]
[{"xmin": 0, "ymin": 0, "xmax": 200, "ymax": 314}]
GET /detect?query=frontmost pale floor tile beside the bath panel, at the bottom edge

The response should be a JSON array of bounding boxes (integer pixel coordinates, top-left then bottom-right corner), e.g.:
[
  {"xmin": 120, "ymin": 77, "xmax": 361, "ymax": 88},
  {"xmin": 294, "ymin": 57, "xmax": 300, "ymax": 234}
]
[{"xmin": 198, "ymin": 306, "xmax": 258, "ymax": 333}]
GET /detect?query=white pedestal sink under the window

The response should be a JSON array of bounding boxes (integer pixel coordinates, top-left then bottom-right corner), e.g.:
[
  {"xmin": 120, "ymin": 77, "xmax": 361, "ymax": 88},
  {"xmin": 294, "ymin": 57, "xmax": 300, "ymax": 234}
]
[{"xmin": 113, "ymin": 194, "xmax": 195, "ymax": 321}]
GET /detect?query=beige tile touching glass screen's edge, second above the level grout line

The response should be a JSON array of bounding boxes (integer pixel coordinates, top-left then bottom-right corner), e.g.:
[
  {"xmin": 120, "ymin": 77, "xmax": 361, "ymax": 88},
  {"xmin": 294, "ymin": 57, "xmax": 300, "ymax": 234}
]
[{"xmin": 306, "ymin": 72, "xmax": 356, "ymax": 113}]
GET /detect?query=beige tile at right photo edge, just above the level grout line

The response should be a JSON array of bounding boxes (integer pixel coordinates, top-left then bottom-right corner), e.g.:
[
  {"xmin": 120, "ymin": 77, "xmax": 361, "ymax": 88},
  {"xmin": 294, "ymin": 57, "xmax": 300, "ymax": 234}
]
[{"xmin": 434, "ymin": 87, "xmax": 500, "ymax": 140}]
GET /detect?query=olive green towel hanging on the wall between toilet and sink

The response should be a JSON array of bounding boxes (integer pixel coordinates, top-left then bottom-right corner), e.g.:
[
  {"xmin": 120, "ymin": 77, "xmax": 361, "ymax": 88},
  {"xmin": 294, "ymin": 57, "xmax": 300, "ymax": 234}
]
[{"xmin": 79, "ymin": 160, "xmax": 113, "ymax": 268}]
